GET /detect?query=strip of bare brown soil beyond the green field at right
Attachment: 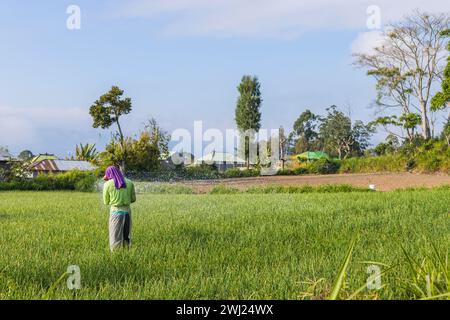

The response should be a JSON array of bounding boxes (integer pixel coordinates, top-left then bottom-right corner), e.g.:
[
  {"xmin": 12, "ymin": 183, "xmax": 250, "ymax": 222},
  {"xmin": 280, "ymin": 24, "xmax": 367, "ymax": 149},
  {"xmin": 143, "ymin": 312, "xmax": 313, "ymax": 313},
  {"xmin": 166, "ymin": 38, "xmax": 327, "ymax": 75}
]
[{"xmin": 179, "ymin": 173, "xmax": 450, "ymax": 193}]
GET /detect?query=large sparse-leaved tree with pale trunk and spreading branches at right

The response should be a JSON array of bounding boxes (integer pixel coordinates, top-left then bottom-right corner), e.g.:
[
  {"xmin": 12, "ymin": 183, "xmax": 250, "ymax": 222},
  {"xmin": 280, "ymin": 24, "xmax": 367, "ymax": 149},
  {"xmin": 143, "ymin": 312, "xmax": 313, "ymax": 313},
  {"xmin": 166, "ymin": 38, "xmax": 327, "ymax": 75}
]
[{"xmin": 355, "ymin": 11, "xmax": 450, "ymax": 139}]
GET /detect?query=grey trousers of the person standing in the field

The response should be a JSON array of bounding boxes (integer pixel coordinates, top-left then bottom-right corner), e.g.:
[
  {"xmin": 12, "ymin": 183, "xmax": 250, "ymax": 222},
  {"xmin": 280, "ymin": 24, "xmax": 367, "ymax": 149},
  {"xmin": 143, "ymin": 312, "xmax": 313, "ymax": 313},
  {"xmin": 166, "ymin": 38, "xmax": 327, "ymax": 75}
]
[{"xmin": 109, "ymin": 213, "xmax": 131, "ymax": 251}]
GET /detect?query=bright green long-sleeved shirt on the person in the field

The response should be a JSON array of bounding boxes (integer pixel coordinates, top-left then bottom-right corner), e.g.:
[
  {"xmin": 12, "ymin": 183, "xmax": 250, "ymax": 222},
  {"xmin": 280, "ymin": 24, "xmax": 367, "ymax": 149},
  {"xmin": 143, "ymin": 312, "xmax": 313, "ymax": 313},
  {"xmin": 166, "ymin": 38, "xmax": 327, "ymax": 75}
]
[{"xmin": 103, "ymin": 179, "xmax": 136, "ymax": 212}]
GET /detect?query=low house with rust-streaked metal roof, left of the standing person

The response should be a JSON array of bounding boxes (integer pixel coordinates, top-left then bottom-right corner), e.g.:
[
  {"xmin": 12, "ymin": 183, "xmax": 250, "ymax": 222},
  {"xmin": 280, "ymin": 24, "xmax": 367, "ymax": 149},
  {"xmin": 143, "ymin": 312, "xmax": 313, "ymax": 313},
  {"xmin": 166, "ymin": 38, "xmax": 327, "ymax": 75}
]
[{"xmin": 30, "ymin": 159, "xmax": 95, "ymax": 177}]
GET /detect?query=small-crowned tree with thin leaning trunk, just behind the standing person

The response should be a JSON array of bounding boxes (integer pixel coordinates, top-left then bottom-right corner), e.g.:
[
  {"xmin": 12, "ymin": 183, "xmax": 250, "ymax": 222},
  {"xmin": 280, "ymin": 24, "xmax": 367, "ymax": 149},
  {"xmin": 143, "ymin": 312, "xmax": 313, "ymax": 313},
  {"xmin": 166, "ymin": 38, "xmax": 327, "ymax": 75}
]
[{"xmin": 89, "ymin": 86, "xmax": 132, "ymax": 172}]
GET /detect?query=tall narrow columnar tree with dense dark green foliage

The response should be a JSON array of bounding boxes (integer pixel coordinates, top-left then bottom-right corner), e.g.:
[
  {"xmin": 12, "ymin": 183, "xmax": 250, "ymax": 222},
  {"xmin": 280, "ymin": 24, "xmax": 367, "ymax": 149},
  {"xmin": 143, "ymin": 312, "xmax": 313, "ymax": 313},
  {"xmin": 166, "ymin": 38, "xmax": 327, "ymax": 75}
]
[{"xmin": 235, "ymin": 75, "xmax": 262, "ymax": 169}]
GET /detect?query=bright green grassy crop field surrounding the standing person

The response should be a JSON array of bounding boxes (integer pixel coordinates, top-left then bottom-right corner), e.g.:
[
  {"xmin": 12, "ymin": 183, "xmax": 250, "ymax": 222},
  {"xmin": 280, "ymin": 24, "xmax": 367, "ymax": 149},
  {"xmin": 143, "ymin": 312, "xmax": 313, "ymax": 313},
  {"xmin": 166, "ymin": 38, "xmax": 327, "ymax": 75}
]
[{"xmin": 0, "ymin": 188, "xmax": 450, "ymax": 299}]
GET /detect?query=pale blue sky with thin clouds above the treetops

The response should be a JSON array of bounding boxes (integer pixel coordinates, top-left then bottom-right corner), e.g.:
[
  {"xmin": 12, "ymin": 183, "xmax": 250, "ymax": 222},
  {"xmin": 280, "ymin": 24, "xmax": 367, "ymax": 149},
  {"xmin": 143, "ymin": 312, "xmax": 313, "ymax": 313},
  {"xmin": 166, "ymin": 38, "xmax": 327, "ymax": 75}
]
[{"xmin": 0, "ymin": 0, "xmax": 450, "ymax": 157}]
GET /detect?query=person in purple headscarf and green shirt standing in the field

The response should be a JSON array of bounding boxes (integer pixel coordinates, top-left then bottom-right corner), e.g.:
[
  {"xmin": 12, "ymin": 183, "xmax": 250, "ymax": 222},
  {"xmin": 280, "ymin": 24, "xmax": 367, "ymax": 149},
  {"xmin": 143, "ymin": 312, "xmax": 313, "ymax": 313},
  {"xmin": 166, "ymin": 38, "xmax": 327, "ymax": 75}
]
[{"xmin": 103, "ymin": 166, "xmax": 136, "ymax": 251}]
